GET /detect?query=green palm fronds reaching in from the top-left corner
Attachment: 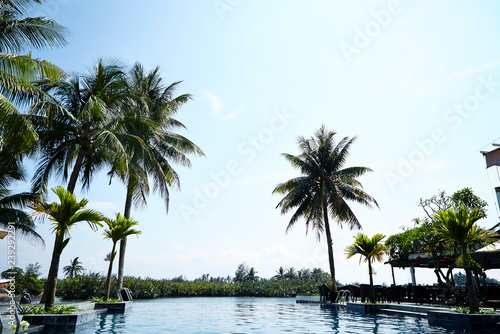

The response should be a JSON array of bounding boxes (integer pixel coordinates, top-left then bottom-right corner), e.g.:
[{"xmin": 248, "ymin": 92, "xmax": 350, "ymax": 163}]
[{"xmin": 0, "ymin": 0, "xmax": 67, "ymax": 153}]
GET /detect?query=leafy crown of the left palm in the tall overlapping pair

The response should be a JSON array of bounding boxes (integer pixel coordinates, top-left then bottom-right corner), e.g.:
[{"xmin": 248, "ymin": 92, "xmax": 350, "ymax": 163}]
[{"xmin": 30, "ymin": 59, "xmax": 141, "ymax": 193}]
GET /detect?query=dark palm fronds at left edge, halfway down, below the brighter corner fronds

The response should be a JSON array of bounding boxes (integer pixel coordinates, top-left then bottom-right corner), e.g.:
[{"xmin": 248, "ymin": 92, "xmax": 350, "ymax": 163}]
[{"xmin": 0, "ymin": 145, "xmax": 45, "ymax": 247}]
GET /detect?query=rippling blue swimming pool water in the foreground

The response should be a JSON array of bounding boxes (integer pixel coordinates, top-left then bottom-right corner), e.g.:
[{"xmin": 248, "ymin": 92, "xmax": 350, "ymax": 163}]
[{"xmin": 34, "ymin": 298, "xmax": 500, "ymax": 334}]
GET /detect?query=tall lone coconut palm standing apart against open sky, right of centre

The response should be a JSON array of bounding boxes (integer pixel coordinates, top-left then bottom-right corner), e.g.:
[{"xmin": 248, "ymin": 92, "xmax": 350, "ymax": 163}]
[{"xmin": 273, "ymin": 125, "xmax": 378, "ymax": 290}]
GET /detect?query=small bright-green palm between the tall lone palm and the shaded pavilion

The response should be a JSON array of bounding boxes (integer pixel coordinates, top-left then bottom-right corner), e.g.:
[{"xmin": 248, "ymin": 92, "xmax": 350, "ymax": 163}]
[{"xmin": 345, "ymin": 233, "xmax": 387, "ymax": 303}]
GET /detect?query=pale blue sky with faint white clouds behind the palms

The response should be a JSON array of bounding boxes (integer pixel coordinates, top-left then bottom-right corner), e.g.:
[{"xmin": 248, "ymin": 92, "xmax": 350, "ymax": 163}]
[{"xmin": 0, "ymin": 0, "xmax": 500, "ymax": 283}]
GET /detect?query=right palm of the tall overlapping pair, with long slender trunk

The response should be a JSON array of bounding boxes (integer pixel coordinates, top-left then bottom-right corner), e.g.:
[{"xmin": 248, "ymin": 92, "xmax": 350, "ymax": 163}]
[{"xmin": 112, "ymin": 63, "xmax": 204, "ymax": 289}]
